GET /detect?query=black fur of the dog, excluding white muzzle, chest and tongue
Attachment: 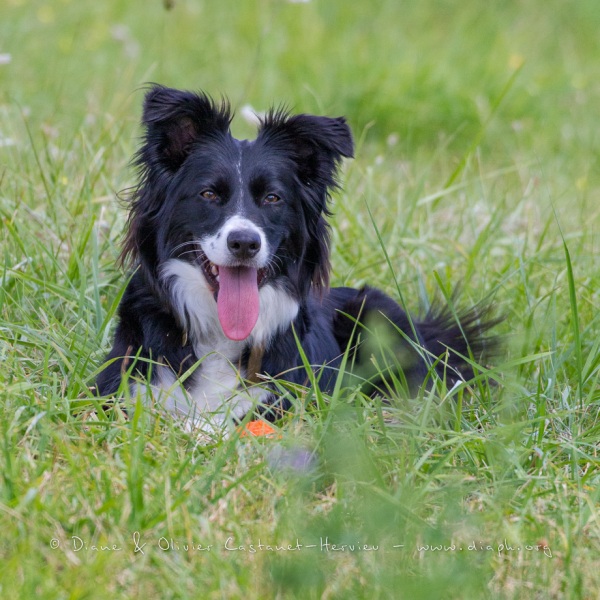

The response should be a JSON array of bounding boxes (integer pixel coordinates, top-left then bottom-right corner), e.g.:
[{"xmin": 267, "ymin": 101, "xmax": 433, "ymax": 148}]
[{"xmin": 97, "ymin": 86, "xmax": 493, "ymax": 422}]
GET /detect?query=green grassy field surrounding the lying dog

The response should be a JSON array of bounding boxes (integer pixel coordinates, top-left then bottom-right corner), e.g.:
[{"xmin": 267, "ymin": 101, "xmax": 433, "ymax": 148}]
[{"xmin": 0, "ymin": 0, "xmax": 600, "ymax": 600}]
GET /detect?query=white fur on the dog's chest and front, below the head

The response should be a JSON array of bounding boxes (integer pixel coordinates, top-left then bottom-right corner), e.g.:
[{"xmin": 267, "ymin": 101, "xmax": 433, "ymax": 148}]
[{"xmin": 141, "ymin": 259, "xmax": 298, "ymax": 426}]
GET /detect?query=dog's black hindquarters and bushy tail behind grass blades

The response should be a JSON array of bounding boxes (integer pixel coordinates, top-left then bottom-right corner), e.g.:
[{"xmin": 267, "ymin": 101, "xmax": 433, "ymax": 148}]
[{"xmin": 330, "ymin": 287, "xmax": 502, "ymax": 394}]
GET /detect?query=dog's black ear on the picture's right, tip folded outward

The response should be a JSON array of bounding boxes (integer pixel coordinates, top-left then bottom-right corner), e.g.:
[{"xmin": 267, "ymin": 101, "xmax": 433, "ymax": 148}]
[{"xmin": 259, "ymin": 111, "xmax": 354, "ymax": 189}]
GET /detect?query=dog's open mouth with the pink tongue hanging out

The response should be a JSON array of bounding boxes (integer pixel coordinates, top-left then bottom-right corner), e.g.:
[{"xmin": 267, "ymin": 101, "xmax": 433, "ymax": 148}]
[{"xmin": 198, "ymin": 251, "xmax": 267, "ymax": 341}]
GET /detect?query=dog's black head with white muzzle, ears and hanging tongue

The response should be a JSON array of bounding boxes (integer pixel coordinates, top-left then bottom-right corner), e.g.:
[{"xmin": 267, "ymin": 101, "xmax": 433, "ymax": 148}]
[{"xmin": 122, "ymin": 86, "xmax": 353, "ymax": 339}]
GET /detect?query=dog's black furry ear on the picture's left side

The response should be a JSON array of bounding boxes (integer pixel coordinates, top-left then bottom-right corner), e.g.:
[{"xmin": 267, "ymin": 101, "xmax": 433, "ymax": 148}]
[{"xmin": 138, "ymin": 85, "xmax": 231, "ymax": 172}]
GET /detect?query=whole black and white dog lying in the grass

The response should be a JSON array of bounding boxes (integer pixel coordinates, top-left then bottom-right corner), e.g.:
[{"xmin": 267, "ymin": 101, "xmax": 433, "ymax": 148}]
[{"xmin": 96, "ymin": 86, "xmax": 491, "ymax": 424}]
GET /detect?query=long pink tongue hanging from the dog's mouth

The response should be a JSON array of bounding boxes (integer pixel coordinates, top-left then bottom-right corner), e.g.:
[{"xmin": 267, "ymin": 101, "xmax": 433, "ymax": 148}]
[{"xmin": 217, "ymin": 267, "xmax": 259, "ymax": 340}]
